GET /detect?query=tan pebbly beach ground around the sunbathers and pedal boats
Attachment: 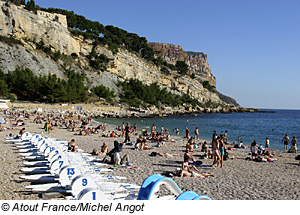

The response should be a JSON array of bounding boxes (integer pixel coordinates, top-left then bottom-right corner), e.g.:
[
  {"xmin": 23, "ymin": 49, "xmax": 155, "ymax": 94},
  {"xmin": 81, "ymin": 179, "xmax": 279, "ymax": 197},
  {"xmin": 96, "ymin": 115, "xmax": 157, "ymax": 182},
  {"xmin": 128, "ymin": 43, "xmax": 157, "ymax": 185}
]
[{"xmin": 0, "ymin": 109, "xmax": 300, "ymax": 200}]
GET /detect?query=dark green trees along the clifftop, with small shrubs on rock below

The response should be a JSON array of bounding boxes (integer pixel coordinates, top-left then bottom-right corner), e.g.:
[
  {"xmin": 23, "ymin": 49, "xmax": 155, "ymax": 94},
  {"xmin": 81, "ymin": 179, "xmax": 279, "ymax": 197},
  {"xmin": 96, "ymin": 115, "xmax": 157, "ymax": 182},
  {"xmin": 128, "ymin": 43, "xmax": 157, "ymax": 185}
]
[{"xmin": 6, "ymin": 0, "xmax": 192, "ymax": 75}]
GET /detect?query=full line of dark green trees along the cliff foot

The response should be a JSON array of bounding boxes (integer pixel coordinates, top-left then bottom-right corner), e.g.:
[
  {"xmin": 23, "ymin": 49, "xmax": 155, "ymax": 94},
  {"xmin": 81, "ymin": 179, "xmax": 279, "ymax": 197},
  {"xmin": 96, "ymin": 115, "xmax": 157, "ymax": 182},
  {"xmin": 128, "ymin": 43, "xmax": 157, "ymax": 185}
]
[{"xmin": 0, "ymin": 68, "xmax": 202, "ymax": 107}]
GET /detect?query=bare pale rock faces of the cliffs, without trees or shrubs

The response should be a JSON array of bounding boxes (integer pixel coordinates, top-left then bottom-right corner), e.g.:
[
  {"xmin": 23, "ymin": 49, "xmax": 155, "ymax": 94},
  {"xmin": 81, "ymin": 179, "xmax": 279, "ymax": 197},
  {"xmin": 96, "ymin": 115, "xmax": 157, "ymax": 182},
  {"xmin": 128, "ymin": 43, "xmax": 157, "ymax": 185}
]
[{"xmin": 0, "ymin": 1, "xmax": 239, "ymax": 108}]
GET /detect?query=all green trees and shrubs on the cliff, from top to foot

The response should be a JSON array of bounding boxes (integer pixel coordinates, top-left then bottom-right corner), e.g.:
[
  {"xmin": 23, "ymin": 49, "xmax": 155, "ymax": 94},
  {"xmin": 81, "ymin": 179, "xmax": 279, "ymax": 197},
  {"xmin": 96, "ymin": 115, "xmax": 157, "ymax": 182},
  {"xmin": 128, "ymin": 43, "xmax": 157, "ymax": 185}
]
[{"xmin": 0, "ymin": 0, "xmax": 219, "ymax": 107}]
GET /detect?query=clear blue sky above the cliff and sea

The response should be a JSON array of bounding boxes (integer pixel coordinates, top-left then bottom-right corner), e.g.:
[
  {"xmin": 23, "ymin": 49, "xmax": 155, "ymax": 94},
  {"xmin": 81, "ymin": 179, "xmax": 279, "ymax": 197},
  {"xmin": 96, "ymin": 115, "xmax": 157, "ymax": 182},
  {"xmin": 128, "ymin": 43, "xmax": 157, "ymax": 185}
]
[{"xmin": 35, "ymin": 0, "xmax": 300, "ymax": 109}]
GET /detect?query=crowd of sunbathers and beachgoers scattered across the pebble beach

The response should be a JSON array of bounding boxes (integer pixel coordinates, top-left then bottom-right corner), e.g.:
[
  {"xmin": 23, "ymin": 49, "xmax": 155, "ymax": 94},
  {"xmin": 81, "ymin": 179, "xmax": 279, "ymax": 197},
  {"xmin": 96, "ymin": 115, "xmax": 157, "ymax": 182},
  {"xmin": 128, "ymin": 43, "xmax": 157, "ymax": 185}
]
[{"xmin": 2, "ymin": 108, "xmax": 298, "ymax": 181}]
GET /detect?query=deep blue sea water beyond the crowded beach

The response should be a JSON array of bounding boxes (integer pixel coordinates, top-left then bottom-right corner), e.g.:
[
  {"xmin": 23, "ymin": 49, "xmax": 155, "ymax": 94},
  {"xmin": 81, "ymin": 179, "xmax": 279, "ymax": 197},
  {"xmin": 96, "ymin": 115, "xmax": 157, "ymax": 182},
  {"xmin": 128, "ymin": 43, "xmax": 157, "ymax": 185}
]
[{"xmin": 95, "ymin": 109, "xmax": 300, "ymax": 149}]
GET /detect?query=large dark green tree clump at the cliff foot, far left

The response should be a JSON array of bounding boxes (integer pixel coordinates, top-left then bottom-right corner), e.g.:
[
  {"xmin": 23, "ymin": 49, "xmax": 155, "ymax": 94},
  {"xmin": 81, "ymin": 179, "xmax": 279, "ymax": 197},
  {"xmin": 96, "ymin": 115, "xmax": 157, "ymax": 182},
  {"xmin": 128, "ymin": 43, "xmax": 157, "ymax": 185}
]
[{"xmin": 0, "ymin": 68, "xmax": 88, "ymax": 103}]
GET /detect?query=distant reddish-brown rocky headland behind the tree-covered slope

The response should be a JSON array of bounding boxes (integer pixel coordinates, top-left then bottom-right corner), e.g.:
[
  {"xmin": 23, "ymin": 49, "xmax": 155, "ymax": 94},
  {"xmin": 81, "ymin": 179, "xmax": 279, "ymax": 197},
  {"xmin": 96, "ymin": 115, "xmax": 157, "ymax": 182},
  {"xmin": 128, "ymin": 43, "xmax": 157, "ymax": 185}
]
[{"xmin": 149, "ymin": 43, "xmax": 216, "ymax": 87}]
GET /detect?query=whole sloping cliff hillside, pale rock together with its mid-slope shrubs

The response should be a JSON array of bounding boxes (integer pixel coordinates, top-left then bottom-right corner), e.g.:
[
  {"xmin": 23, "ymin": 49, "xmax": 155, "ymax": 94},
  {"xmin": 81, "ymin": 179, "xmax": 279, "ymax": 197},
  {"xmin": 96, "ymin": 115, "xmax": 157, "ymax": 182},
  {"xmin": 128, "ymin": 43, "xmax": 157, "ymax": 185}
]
[{"xmin": 0, "ymin": 1, "xmax": 238, "ymax": 112}]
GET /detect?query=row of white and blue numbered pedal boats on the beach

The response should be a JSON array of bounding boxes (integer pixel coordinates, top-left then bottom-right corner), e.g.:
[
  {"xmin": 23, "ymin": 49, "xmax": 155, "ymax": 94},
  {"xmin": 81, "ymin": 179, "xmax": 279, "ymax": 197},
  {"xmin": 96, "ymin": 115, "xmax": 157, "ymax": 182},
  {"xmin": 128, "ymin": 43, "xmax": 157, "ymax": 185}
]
[{"xmin": 6, "ymin": 132, "xmax": 210, "ymax": 200}]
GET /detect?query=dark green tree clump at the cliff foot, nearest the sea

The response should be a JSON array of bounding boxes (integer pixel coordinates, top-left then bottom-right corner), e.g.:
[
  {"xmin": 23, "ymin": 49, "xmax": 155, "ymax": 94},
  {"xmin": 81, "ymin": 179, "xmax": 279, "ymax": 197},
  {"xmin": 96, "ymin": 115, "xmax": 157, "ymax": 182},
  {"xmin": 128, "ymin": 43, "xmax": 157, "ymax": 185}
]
[{"xmin": 118, "ymin": 79, "xmax": 201, "ymax": 107}]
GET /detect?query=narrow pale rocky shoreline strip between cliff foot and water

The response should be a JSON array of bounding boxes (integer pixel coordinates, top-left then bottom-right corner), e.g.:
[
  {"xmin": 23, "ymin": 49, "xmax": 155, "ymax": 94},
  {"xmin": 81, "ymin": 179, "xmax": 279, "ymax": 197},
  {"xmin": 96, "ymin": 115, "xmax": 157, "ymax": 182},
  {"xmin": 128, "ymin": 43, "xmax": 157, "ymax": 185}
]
[{"xmin": 8, "ymin": 102, "xmax": 272, "ymax": 118}]
